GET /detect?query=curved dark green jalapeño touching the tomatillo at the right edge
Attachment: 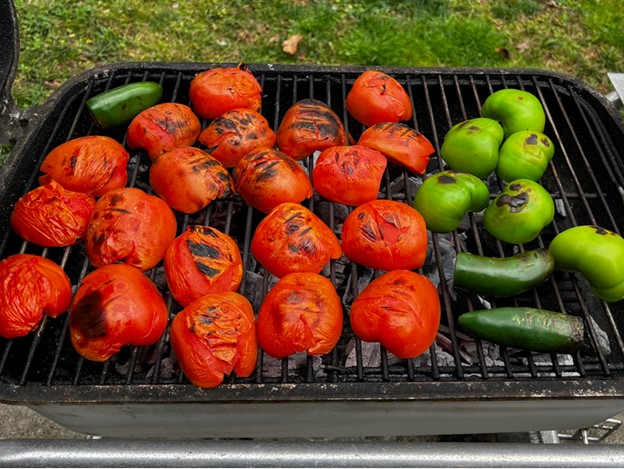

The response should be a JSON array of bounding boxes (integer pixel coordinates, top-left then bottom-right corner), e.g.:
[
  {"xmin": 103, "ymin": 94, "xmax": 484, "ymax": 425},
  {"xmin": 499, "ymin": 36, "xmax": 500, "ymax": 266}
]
[{"xmin": 453, "ymin": 248, "xmax": 555, "ymax": 296}]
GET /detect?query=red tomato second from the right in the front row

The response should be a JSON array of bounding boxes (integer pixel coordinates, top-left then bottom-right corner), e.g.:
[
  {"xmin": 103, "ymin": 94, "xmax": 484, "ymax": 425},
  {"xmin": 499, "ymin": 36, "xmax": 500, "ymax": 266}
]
[{"xmin": 257, "ymin": 272, "xmax": 343, "ymax": 358}]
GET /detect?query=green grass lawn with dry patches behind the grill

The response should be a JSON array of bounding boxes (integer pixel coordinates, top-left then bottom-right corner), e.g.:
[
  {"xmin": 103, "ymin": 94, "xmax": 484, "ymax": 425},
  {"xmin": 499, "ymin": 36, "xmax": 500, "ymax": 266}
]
[{"xmin": 7, "ymin": 0, "xmax": 624, "ymax": 107}]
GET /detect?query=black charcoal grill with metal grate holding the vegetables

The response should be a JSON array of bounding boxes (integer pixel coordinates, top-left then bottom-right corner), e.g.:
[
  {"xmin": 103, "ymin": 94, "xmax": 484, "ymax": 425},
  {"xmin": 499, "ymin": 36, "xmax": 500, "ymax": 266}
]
[{"xmin": 0, "ymin": 0, "xmax": 624, "ymax": 446}]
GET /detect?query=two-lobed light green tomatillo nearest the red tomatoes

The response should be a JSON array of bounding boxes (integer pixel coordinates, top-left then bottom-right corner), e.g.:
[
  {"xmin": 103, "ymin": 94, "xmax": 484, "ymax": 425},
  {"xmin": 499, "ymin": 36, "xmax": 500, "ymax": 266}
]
[{"xmin": 414, "ymin": 170, "xmax": 490, "ymax": 233}]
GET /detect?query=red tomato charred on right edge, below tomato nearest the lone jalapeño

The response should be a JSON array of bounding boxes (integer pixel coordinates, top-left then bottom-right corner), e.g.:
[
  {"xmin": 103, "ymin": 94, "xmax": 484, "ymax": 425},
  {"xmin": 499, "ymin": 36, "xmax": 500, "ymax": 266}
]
[{"xmin": 149, "ymin": 147, "xmax": 234, "ymax": 213}]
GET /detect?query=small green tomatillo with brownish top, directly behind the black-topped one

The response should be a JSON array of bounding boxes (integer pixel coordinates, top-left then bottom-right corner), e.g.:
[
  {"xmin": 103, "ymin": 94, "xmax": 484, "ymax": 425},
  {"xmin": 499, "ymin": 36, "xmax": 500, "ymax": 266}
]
[{"xmin": 496, "ymin": 130, "xmax": 555, "ymax": 182}]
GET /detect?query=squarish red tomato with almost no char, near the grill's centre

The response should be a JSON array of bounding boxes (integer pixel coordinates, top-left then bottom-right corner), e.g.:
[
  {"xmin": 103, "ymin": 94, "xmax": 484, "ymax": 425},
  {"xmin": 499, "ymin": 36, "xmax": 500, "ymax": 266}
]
[{"xmin": 312, "ymin": 145, "xmax": 388, "ymax": 205}]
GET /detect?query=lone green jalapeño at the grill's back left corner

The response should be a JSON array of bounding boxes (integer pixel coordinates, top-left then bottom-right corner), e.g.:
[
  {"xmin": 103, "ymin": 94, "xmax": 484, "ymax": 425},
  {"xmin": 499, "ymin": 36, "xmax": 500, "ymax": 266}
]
[{"xmin": 87, "ymin": 81, "xmax": 163, "ymax": 129}]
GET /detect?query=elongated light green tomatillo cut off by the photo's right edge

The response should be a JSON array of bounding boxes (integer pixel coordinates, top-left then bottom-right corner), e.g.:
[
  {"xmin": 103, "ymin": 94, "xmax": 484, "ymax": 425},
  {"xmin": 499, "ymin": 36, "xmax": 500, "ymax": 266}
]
[{"xmin": 549, "ymin": 225, "xmax": 624, "ymax": 302}]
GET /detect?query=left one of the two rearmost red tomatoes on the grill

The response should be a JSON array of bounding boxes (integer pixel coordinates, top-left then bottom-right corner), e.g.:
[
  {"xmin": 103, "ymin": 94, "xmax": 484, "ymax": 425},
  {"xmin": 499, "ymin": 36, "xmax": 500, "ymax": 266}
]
[{"xmin": 189, "ymin": 63, "xmax": 262, "ymax": 120}]
